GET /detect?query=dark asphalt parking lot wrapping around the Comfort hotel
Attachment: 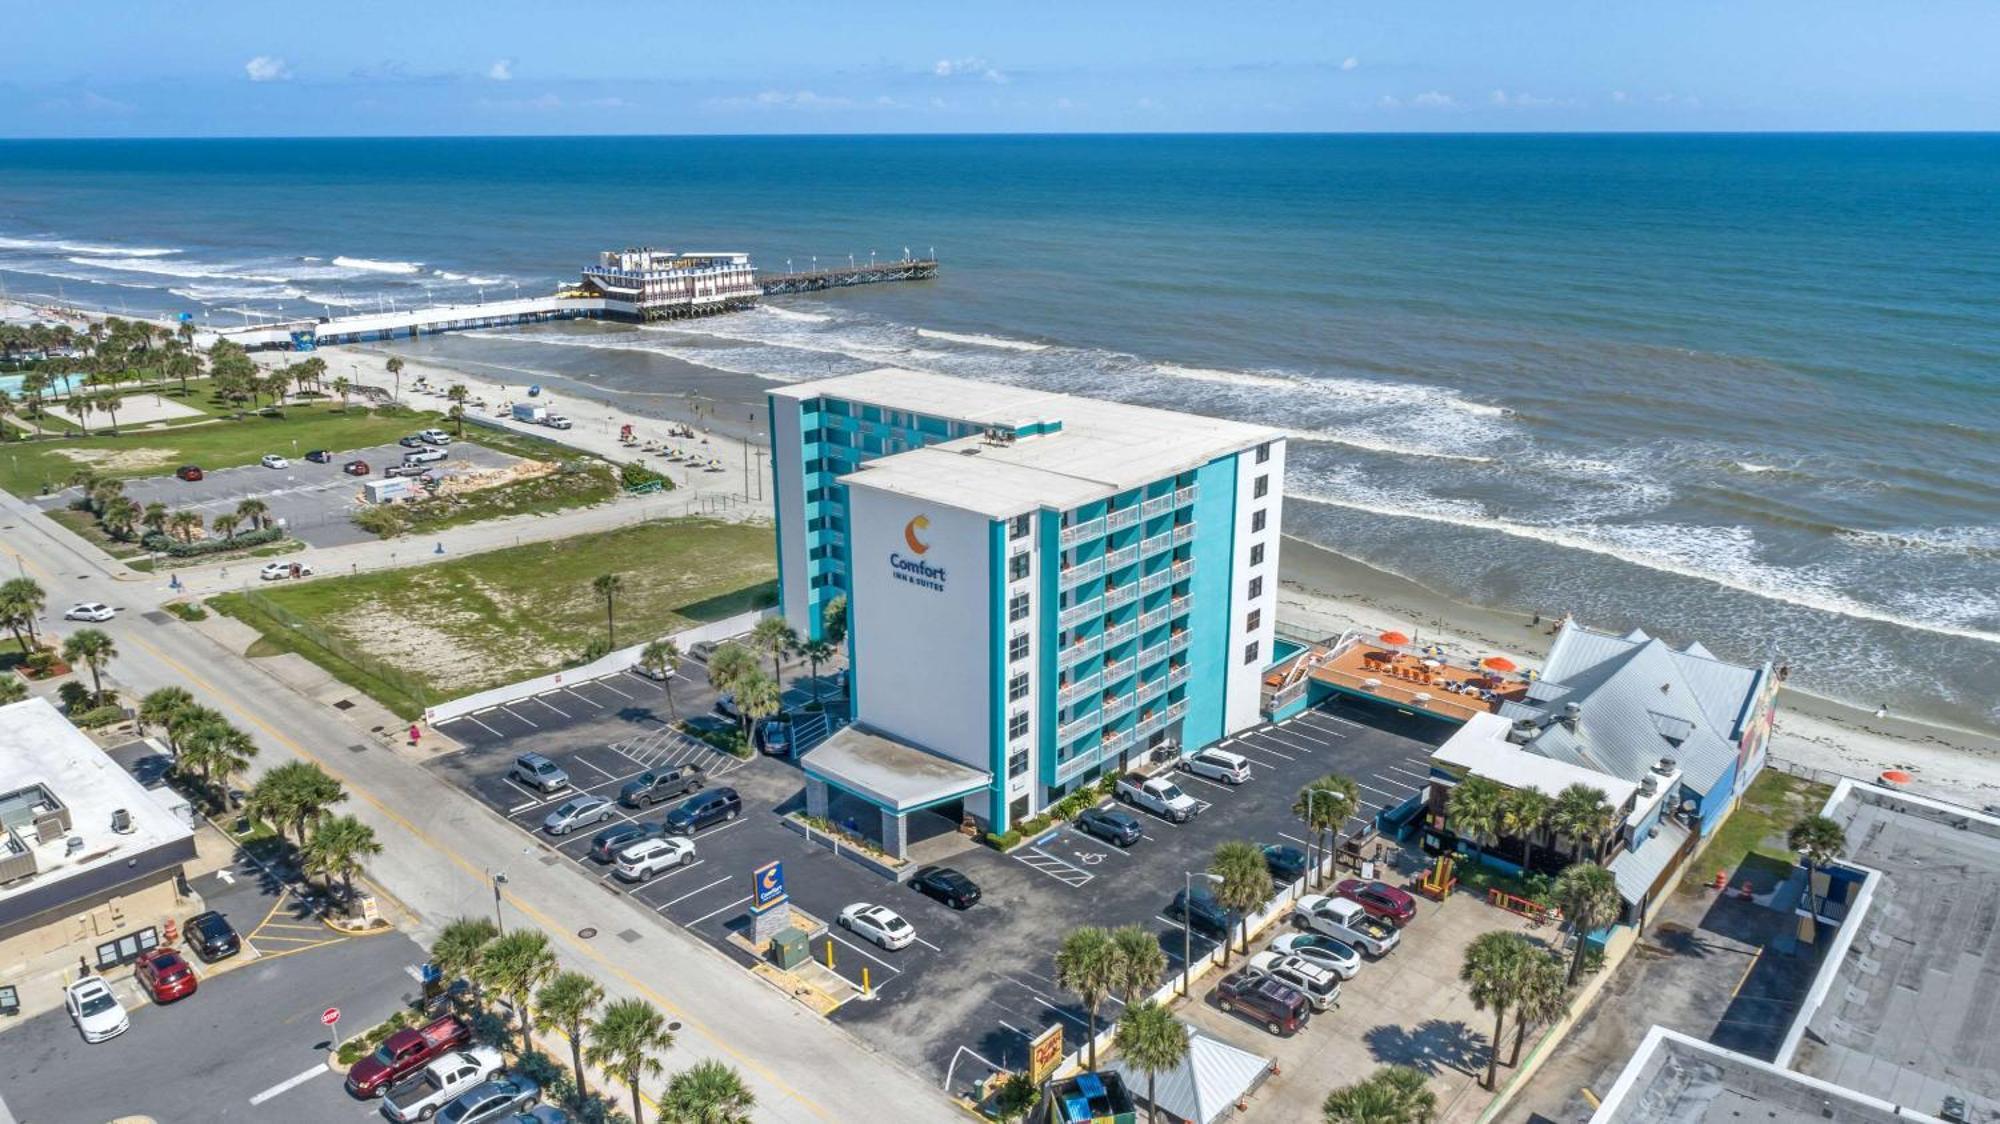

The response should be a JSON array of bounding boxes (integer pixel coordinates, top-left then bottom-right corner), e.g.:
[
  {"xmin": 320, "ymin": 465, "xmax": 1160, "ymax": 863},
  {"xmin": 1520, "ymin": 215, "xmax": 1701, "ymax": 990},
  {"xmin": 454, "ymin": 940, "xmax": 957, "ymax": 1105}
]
[{"xmin": 432, "ymin": 660, "xmax": 1430, "ymax": 1088}]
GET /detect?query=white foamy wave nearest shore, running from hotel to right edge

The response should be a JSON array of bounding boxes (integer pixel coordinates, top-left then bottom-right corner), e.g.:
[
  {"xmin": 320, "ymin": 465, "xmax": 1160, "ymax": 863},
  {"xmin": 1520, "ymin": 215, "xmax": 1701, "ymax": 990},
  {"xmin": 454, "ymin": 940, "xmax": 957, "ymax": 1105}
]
[{"xmin": 1288, "ymin": 490, "xmax": 2000, "ymax": 644}]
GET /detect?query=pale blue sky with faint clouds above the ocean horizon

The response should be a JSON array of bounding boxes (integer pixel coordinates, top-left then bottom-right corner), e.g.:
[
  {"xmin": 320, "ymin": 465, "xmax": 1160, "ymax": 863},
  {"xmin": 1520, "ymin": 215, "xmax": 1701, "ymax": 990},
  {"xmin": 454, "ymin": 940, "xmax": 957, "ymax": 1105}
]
[{"xmin": 0, "ymin": 0, "xmax": 2000, "ymax": 136}]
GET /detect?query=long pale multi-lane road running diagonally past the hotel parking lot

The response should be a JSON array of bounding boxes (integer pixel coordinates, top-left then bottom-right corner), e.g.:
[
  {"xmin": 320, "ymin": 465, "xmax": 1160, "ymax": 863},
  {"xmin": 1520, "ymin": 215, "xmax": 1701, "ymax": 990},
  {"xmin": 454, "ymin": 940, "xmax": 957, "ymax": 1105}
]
[{"xmin": 0, "ymin": 488, "xmax": 958, "ymax": 1122}]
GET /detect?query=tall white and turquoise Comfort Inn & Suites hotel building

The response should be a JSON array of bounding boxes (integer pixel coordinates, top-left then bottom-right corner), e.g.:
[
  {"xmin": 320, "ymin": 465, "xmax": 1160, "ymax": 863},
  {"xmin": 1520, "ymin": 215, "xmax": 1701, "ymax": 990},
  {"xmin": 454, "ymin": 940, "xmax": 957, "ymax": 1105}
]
[{"xmin": 770, "ymin": 370, "xmax": 1284, "ymax": 854}]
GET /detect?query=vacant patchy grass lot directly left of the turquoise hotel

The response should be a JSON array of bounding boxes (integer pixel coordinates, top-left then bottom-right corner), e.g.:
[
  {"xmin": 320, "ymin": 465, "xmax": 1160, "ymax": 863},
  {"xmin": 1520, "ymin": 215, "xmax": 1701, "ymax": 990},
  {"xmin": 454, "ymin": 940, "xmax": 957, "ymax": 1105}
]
[{"xmin": 208, "ymin": 518, "xmax": 778, "ymax": 716}]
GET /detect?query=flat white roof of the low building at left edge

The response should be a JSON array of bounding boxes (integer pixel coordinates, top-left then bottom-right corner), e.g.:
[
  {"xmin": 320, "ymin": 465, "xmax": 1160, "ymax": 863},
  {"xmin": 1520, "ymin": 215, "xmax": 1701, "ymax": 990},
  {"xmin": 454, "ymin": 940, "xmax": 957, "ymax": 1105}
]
[{"xmin": 0, "ymin": 698, "xmax": 194, "ymax": 900}]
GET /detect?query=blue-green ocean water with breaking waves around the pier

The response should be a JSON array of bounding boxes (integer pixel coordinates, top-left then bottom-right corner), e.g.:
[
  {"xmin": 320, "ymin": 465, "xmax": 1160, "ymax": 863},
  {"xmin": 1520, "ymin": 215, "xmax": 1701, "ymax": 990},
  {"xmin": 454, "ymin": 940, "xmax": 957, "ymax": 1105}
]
[{"xmin": 0, "ymin": 136, "xmax": 2000, "ymax": 730}]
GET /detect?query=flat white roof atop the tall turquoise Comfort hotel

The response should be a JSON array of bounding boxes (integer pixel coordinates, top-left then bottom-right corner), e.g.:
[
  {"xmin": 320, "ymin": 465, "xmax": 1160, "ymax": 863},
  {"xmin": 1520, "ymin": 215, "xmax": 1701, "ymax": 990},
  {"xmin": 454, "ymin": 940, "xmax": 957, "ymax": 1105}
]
[{"xmin": 772, "ymin": 368, "xmax": 1284, "ymax": 516}]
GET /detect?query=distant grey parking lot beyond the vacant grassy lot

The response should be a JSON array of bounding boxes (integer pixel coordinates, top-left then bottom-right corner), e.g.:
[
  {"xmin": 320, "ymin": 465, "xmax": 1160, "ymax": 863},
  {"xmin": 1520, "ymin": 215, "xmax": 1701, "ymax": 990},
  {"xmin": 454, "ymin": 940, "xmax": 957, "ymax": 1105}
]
[{"xmin": 36, "ymin": 442, "xmax": 520, "ymax": 546}]
